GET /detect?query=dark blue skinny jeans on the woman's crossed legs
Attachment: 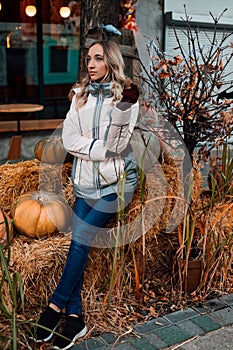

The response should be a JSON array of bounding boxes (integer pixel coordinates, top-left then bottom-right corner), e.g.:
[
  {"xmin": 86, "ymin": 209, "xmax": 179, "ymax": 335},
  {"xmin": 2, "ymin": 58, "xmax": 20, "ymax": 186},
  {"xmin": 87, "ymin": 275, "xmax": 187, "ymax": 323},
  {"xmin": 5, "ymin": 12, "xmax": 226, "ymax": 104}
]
[{"xmin": 49, "ymin": 193, "xmax": 132, "ymax": 315}]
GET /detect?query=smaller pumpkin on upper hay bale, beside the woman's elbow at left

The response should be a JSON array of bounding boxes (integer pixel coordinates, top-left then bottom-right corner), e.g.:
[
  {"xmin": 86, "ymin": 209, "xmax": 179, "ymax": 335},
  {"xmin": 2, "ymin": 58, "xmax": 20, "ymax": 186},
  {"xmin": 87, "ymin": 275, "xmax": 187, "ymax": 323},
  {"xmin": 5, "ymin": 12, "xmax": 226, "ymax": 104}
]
[{"xmin": 34, "ymin": 136, "xmax": 70, "ymax": 164}]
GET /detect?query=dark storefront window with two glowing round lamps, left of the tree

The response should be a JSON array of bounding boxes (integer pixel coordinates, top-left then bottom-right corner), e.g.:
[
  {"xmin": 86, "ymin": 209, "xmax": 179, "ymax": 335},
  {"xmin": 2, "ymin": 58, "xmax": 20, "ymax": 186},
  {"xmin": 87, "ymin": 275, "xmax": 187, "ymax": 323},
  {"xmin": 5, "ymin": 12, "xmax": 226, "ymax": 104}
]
[{"xmin": 0, "ymin": 0, "xmax": 81, "ymax": 118}]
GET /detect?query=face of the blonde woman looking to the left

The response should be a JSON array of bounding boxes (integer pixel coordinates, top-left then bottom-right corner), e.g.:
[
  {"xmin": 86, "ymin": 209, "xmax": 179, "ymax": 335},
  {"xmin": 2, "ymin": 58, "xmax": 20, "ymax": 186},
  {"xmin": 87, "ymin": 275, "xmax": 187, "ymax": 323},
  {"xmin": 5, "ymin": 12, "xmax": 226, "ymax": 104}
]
[{"xmin": 86, "ymin": 44, "xmax": 108, "ymax": 82}]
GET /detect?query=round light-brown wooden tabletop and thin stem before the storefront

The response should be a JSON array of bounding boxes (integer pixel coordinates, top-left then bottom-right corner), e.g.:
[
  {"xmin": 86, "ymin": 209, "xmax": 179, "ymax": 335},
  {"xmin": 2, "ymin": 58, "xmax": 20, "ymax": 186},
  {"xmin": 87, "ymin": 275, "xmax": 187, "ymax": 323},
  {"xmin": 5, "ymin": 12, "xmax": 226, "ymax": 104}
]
[{"xmin": 0, "ymin": 103, "xmax": 44, "ymax": 134}]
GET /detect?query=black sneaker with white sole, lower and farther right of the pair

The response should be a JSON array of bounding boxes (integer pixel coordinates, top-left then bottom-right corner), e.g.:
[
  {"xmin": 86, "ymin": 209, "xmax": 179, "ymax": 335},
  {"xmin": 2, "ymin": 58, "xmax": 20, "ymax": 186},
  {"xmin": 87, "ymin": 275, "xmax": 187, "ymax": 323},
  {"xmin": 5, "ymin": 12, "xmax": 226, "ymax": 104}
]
[{"xmin": 53, "ymin": 315, "xmax": 87, "ymax": 350}]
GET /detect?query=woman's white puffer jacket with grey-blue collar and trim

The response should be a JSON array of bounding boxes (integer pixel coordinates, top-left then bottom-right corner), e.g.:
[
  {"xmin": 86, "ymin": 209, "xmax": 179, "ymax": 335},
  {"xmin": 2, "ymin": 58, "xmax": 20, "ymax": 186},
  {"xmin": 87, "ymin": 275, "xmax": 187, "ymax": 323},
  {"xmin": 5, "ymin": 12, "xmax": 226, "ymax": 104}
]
[{"xmin": 62, "ymin": 83, "xmax": 139, "ymax": 198}]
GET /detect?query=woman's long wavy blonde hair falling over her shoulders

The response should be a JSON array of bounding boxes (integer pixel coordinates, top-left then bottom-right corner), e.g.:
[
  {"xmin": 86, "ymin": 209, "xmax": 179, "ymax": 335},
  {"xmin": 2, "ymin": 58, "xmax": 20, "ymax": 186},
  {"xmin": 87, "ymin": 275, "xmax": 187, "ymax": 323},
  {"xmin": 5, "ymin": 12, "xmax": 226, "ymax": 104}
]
[{"xmin": 69, "ymin": 40, "xmax": 131, "ymax": 107}]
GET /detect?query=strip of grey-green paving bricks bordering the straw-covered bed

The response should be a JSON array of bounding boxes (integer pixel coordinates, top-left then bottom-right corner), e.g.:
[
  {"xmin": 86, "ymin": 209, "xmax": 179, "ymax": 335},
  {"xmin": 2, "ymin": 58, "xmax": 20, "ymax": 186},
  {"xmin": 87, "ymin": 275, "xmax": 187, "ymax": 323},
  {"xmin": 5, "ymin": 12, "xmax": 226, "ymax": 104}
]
[{"xmin": 71, "ymin": 294, "xmax": 233, "ymax": 350}]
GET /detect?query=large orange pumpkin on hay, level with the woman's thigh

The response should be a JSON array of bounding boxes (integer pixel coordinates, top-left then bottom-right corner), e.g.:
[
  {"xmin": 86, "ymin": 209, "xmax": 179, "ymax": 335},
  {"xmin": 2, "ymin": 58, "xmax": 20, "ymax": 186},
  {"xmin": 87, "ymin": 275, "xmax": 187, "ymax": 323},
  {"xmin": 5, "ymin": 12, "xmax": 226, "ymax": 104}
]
[{"xmin": 12, "ymin": 192, "xmax": 72, "ymax": 238}]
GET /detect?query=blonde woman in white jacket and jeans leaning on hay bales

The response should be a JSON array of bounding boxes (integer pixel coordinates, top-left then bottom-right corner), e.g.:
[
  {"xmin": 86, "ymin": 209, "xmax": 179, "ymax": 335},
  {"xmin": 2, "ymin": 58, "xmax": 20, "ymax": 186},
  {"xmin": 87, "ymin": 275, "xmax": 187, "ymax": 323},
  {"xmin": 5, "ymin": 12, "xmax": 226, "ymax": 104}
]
[{"xmin": 34, "ymin": 41, "xmax": 139, "ymax": 350}]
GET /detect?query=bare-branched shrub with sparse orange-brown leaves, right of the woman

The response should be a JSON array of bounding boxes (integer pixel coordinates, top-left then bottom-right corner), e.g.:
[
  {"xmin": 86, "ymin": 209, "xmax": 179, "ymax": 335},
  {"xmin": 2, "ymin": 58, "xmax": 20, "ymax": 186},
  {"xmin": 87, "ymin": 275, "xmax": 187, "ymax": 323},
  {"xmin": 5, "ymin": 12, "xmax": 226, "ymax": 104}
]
[{"xmin": 138, "ymin": 8, "xmax": 233, "ymax": 161}]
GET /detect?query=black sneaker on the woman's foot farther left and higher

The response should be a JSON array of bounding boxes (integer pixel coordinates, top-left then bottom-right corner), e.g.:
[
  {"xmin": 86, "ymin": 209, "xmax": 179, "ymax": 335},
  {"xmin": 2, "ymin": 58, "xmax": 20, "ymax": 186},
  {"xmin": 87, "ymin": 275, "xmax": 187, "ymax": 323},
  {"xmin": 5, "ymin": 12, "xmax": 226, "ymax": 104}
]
[{"xmin": 32, "ymin": 306, "xmax": 62, "ymax": 343}]
